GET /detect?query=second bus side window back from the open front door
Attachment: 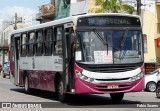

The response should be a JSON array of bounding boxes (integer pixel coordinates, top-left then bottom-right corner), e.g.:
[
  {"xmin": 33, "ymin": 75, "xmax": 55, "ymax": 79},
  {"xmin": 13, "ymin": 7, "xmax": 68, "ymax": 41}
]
[{"xmin": 44, "ymin": 28, "xmax": 53, "ymax": 55}]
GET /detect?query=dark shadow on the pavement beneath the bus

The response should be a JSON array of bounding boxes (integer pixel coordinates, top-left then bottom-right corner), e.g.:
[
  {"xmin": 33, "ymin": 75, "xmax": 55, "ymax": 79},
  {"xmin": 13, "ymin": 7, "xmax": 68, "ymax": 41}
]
[{"xmin": 10, "ymin": 88, "xmax": 141, "ymax": 108}]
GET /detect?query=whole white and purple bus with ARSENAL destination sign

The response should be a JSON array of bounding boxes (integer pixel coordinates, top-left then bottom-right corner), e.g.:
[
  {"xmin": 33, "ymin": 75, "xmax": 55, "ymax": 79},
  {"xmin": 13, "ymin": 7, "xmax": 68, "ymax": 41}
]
[{"xmin": 10, "ymin": 14, "xmax": 144, "ymax": 101}]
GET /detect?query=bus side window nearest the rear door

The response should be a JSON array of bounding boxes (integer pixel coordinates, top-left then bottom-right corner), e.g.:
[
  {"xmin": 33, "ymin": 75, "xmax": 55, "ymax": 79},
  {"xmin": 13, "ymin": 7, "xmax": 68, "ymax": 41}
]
[{"xmin": 21, "ymin": 34, "xmax": 27, "ymax": 56}]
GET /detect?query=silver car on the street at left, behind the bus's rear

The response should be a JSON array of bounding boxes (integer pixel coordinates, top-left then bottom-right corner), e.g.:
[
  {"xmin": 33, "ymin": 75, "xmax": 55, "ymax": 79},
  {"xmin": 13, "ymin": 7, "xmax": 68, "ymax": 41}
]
[{"xmin": 2, "ymin": 62, "xmax": 10, "ymax": 78}]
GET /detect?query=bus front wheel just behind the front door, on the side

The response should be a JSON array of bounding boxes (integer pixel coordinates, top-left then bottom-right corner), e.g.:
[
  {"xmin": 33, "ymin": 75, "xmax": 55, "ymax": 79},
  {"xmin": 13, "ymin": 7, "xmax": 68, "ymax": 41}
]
[{"xmin": 57, "ymin": 79, "xmax": 66, "ymax": 102}]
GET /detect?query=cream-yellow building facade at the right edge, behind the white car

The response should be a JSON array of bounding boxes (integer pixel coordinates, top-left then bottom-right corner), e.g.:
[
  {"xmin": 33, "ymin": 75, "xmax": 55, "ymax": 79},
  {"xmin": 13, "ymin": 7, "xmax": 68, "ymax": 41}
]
[{"xmin": 141, "ymin": 0, "xmax": 160, "ymax": 74}]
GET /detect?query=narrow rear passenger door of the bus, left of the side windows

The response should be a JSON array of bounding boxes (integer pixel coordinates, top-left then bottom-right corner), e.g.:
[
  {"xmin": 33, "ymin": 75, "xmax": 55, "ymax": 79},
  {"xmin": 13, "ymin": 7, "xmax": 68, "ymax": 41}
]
[{"xmin": 14, "ymin": 35, "xmax": 20, "ymax": 85}]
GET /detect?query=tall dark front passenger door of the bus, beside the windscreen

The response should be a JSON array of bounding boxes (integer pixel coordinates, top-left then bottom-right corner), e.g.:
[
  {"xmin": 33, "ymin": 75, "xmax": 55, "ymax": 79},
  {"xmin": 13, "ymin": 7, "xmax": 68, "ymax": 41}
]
[{"xmin": 63, "ymin": 24, "xmax": 74, "ymax": 92}]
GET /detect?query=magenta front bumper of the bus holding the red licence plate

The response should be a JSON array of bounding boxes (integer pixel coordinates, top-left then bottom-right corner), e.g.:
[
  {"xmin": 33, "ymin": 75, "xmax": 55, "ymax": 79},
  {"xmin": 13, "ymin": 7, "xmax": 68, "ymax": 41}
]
[{"xmin": 75, "ymin": 77, "xmax": 144, "ymax": 94}]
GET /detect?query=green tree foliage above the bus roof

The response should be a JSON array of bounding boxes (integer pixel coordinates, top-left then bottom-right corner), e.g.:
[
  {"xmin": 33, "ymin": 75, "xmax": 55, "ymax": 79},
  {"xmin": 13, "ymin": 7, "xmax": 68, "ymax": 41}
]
[{"xmin": 90, "ymin": 0, "xmax": 134, "ymax": 14}]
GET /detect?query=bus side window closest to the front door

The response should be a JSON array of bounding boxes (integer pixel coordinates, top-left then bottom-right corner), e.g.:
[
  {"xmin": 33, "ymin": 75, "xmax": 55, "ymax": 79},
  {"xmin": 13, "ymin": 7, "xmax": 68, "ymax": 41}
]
[{"xmin": 54, "ymin": 27, "xmax": 63, "ymax": 54}]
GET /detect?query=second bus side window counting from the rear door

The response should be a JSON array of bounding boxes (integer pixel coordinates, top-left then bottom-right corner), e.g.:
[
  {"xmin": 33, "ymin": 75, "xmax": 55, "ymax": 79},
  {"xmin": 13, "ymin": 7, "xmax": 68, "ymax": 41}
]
[{"xmin": 28, "ymin": 32, "xmax": 35, "ymax": 56}]
